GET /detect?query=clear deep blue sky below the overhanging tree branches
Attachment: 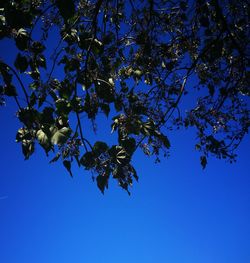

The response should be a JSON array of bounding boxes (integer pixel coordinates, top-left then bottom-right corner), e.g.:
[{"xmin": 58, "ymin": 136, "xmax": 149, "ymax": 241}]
[{"xmin": 0, "ymin": 21, "xmax": 250, "ymax": 263}]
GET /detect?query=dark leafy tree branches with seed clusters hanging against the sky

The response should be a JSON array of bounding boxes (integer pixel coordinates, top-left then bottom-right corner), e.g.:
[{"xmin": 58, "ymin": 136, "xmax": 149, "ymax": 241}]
[{"xmin": 0, "ymin": 0, "xmax": 250, "ymax": 192}]
